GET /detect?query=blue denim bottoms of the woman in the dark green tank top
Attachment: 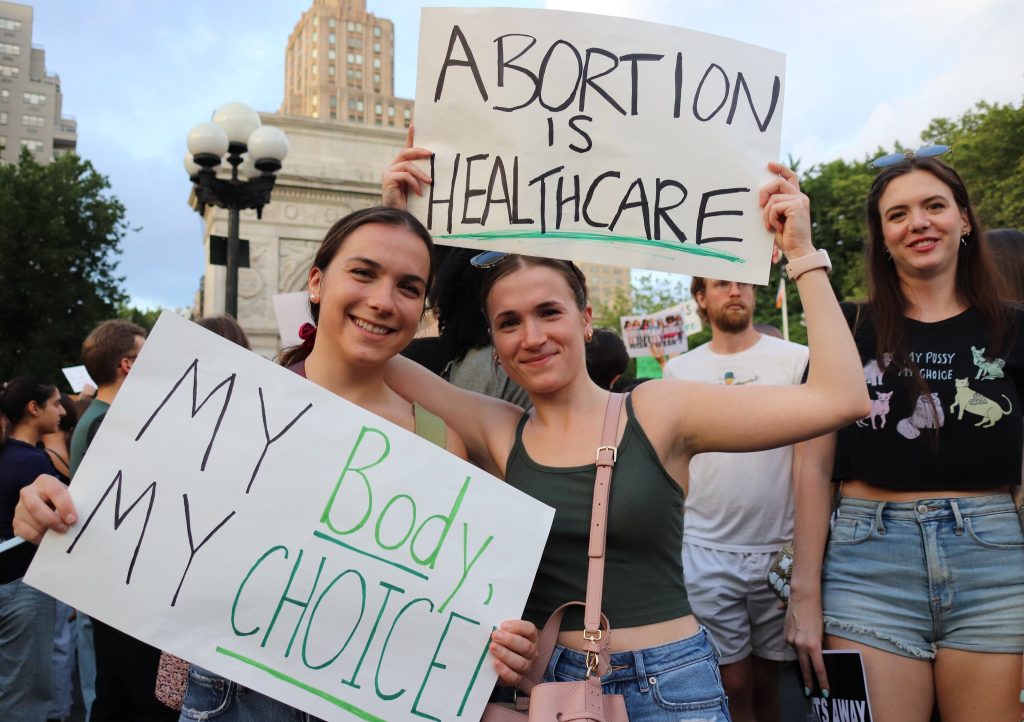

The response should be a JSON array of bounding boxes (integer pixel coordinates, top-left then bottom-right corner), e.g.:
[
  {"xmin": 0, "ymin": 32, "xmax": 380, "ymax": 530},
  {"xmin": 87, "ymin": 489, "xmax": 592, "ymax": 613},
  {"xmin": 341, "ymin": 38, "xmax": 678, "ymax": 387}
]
[{"xmin": 501, "ymin": 627, "xmax": 731, "ymax": 722}]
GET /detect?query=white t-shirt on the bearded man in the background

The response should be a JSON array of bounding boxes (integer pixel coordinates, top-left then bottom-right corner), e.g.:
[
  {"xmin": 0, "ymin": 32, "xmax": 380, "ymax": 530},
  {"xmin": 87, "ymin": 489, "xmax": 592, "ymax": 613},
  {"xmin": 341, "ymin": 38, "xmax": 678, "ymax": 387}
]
[{"xmin": 665, "ymin": 335, "xmax": 807, "ymax": 552}]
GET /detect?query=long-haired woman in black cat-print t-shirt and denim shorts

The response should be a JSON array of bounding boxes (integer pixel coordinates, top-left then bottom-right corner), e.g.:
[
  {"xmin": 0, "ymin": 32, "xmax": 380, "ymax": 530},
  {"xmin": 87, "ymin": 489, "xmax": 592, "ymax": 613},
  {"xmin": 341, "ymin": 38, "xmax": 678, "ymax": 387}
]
[{"xmin": 786, "ymin": 150, "xmax": 1024, "ymax": 722}]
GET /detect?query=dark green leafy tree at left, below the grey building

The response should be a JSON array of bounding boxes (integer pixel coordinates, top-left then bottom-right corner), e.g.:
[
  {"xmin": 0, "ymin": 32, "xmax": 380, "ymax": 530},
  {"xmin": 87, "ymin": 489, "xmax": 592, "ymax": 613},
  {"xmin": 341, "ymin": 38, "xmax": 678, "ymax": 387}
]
[{"xmin": 0, "ymin": 151, "xmax": 127, "ymax": 380}]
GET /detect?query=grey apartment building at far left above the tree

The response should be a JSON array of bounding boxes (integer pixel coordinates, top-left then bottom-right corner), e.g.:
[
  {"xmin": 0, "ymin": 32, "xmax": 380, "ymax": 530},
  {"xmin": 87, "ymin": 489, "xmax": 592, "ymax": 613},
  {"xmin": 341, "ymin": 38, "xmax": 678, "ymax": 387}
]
[{"xmin": 0, "ymin": 1, "xmax": 78, "ymax": 163}]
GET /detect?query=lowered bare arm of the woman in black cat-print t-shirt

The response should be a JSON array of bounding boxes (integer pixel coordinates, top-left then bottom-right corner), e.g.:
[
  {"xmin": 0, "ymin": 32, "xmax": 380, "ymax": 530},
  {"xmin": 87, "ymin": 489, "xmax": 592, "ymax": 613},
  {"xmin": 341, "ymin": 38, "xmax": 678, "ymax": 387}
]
[{"xmin": 785, "ymin": 433, "xmax": 836, "ymax": 694}]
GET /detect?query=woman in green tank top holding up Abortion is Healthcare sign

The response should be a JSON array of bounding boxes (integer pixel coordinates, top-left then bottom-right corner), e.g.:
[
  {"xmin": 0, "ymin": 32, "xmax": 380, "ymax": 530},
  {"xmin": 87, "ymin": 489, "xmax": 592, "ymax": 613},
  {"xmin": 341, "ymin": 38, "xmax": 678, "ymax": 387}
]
[{"xmin": 384, "ymin": 138, "xmax": 867, "ymax": 722}]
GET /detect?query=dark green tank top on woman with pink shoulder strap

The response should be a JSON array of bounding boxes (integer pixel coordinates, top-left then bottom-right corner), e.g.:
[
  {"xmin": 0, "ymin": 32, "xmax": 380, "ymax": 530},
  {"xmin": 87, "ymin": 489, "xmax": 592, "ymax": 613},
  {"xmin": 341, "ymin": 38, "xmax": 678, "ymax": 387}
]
[{"xmin": 505, "ymin": 397, "xmax": 690, "ymax": 630}]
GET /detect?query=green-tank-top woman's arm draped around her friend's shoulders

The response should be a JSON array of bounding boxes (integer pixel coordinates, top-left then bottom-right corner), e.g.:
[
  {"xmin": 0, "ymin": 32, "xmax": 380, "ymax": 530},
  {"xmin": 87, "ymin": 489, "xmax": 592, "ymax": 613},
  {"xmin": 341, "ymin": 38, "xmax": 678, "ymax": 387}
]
[{"xmin": 384, "ymin": 355, "xmax": 522, "ymax": 477}]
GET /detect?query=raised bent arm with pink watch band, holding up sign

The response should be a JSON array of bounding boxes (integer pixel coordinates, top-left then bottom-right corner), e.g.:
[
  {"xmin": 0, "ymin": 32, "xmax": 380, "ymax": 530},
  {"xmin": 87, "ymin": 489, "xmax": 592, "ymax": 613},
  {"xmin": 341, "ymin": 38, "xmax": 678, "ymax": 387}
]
[{"xmin": 635, "ymin": 163, "xmax": 870, "ymax": 458}]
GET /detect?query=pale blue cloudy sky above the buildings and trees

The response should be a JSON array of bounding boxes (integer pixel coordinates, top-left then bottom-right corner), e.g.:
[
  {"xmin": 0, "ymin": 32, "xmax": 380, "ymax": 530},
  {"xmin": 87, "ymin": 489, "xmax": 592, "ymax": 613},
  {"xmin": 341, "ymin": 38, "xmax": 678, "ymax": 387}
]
[{"xmin": 22, "ymin": 0, "xmax": 1024, "ymax": 307}]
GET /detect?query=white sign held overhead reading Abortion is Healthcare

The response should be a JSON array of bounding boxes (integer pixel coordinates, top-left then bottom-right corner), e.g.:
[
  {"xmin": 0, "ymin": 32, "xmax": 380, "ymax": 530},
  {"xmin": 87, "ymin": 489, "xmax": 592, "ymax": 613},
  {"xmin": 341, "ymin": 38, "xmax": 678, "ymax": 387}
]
[{"xmin": 410, "ymin": 8, "xmax": 785, "ymax": 284}]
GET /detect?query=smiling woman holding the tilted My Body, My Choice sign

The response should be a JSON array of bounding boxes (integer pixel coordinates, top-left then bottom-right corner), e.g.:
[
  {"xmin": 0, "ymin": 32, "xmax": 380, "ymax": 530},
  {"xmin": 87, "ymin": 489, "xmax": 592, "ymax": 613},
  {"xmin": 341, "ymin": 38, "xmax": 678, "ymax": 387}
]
[{"xmin": 15, "ymin": 208, "xmax": 537, "ymax": 722}]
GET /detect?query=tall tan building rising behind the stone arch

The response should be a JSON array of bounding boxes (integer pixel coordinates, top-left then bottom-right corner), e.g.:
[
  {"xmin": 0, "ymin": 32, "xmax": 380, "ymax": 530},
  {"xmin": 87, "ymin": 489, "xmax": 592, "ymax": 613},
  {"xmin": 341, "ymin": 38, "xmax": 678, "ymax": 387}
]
[{"xmin": 281, "ymin": 0, "xmax": 413, "ymax": 128}]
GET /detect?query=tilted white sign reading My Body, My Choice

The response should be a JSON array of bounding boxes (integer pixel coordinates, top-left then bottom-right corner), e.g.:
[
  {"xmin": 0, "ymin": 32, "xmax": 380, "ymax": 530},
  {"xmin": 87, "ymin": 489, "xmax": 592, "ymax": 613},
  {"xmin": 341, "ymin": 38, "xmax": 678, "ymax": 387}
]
[{"xmin": 27, "ymin": 313, "xmax": 553, "ymax": 721}]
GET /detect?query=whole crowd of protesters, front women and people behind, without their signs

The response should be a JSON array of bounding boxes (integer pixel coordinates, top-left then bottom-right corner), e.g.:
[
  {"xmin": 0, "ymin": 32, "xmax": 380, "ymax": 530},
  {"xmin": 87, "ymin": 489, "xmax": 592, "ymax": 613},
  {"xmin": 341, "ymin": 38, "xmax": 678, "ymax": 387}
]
[{"xmin": 0, "ymin": 143, "xmax": 1024, "ymax": 722}]
